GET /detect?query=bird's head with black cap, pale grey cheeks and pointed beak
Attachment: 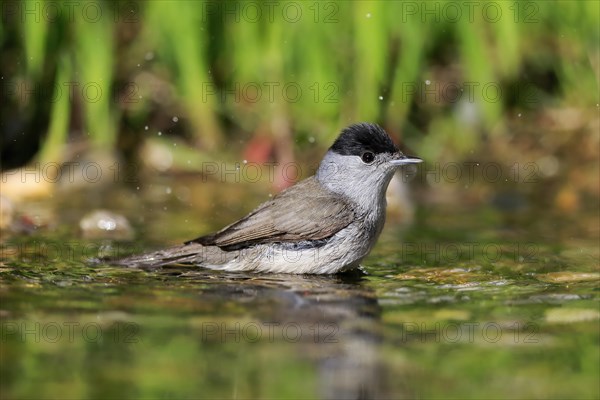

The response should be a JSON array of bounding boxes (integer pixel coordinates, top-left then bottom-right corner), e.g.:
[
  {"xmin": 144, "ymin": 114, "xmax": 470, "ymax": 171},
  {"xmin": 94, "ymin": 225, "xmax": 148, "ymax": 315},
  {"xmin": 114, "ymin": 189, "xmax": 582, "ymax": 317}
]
[{"xmin": 316, "ymin": 123, "xmax": 421, "ymax": 209}]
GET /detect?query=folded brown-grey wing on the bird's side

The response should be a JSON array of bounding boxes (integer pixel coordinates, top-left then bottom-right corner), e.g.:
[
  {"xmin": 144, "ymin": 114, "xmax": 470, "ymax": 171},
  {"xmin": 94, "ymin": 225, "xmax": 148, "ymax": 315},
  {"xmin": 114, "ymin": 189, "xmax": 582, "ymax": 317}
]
[{"xmin": 187, "ymin": 177, "xmax": 354, "ymax": 249}]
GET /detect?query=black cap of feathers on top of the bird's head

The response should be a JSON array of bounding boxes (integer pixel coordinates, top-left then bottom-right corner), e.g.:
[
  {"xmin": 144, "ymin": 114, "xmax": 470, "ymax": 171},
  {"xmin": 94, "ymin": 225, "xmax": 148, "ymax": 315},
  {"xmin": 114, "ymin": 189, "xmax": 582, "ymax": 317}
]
[{"xmin": 329, "ymin": 122, "xmax": 398, "ymax": 156}]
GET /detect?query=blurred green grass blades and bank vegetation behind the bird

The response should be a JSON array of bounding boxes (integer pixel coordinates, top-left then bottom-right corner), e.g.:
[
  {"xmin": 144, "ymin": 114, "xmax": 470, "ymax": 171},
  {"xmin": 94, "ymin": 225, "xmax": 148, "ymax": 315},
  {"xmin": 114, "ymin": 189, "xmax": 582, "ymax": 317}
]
[{"xmin": 0, "ymin": 1, "xmax": 600, "ymax": 216}]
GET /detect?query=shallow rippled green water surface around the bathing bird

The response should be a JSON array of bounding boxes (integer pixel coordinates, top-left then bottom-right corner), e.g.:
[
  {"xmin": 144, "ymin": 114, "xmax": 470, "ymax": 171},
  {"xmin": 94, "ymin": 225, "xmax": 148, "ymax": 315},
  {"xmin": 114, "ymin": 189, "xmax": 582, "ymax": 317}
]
[{"xmin": 0, "ymin": 183, "xmax": 600, "ymax": 398}]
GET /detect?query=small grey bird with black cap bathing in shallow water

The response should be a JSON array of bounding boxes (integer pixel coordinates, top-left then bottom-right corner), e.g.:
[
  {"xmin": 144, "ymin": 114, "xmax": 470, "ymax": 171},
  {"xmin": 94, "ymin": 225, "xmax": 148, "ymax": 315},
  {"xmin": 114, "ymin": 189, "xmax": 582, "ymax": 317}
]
[{"xmin": 118, "ymin": 123, "xmax": 422, "ymax": 274}]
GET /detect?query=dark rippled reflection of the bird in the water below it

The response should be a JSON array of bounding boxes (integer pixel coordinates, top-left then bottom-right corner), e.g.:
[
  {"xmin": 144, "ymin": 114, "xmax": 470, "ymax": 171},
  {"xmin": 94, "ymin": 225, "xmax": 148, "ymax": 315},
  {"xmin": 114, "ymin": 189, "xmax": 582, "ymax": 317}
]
[{"xmin": 155, "ymin": 268, "xmax": 397, "ymax": 399}]
